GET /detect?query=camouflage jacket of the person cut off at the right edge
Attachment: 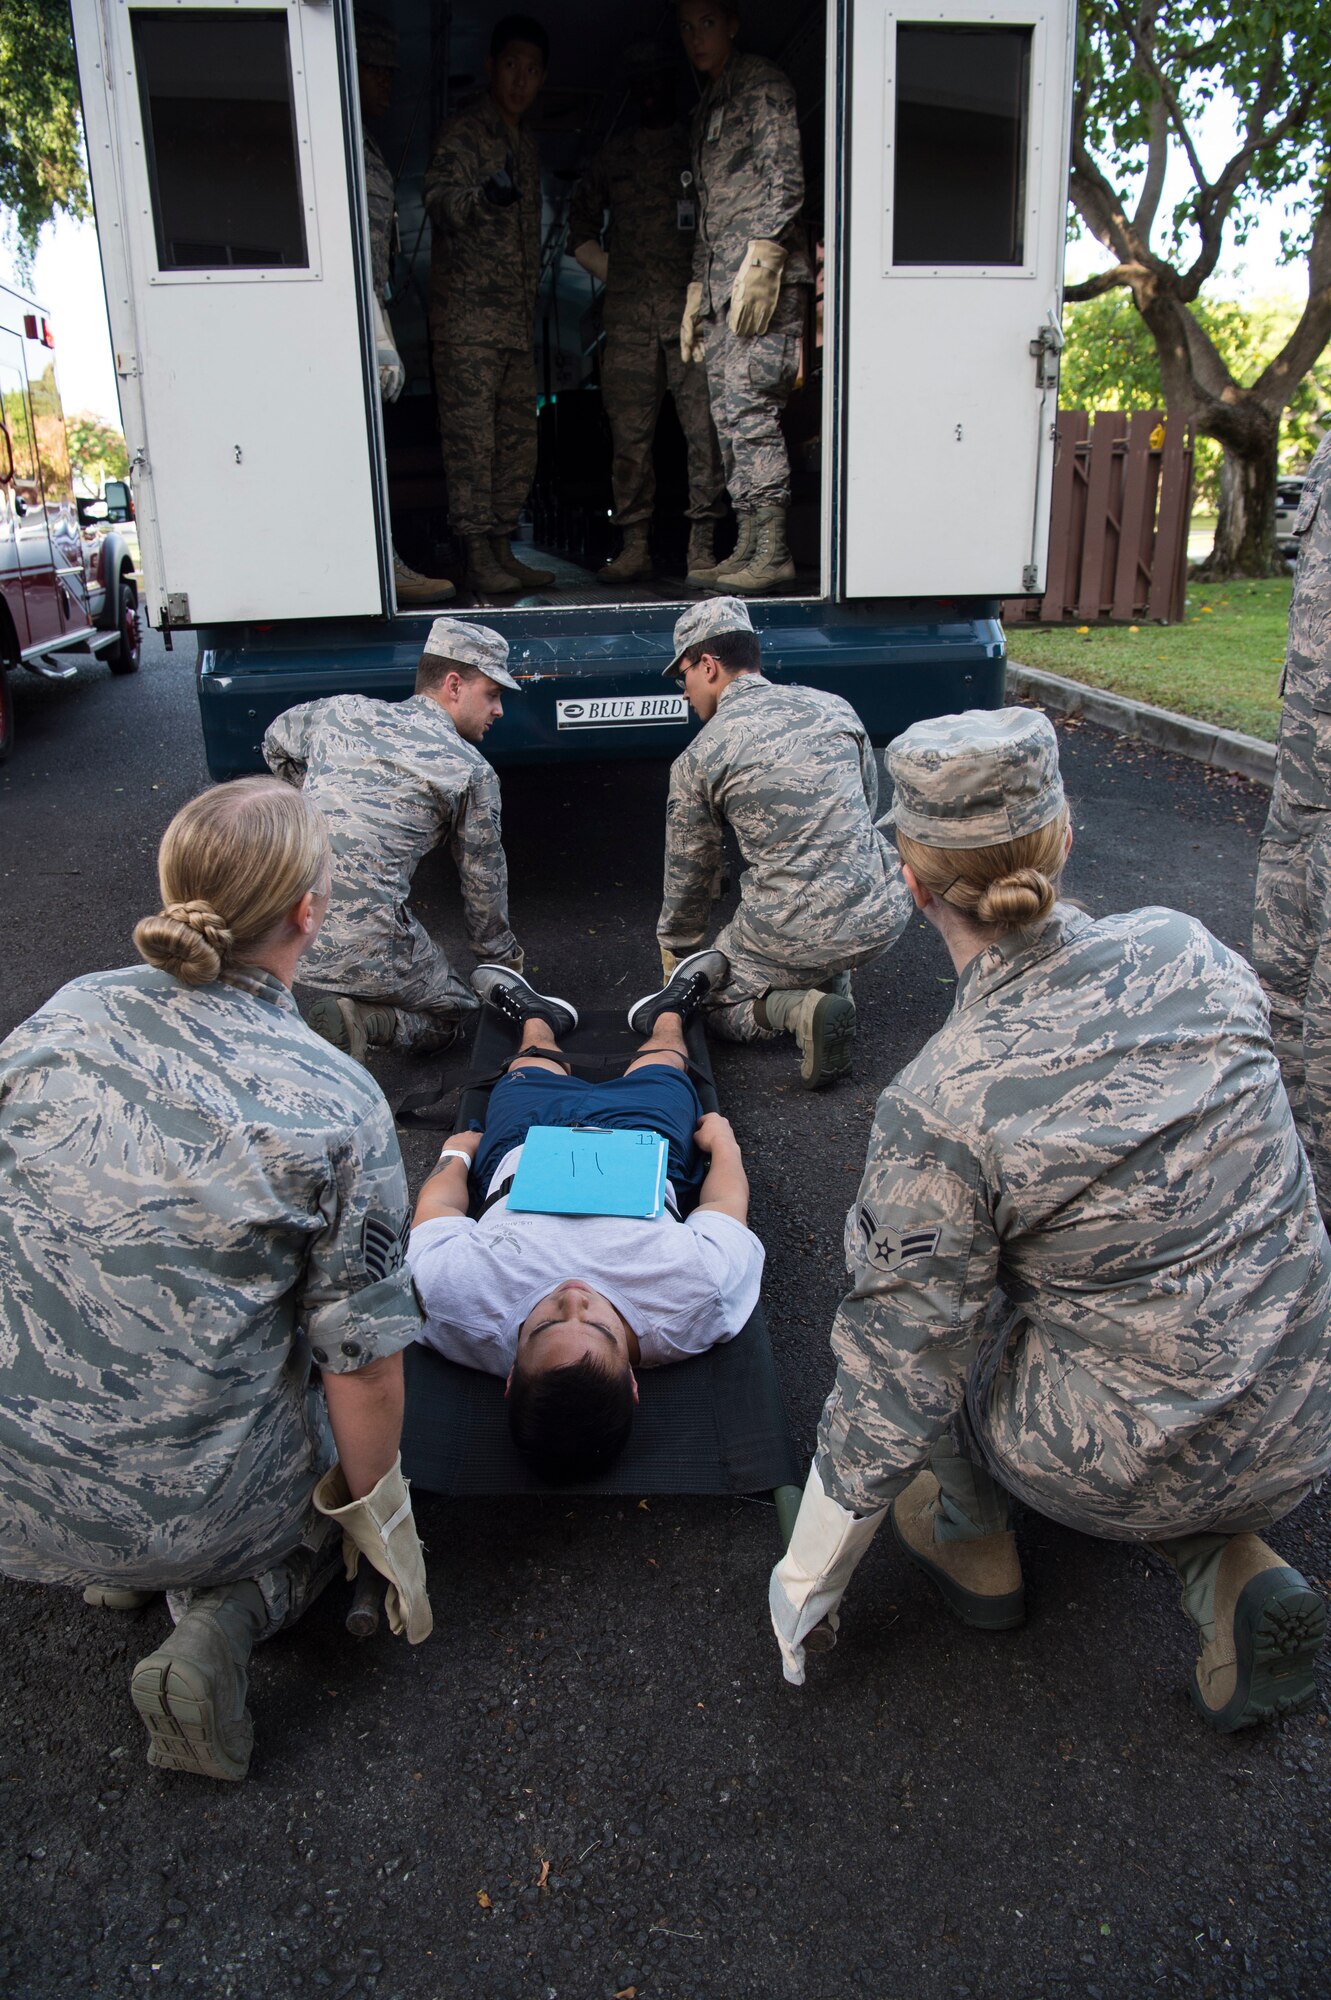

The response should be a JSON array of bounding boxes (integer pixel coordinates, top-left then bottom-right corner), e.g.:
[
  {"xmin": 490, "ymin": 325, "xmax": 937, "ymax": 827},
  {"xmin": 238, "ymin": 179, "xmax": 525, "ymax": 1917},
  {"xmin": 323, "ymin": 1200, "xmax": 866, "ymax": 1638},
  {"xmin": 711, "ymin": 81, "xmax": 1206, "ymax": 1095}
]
[{"xmin": 1277, "ymin": 432, "xmax": 1331, "ymax": 812}]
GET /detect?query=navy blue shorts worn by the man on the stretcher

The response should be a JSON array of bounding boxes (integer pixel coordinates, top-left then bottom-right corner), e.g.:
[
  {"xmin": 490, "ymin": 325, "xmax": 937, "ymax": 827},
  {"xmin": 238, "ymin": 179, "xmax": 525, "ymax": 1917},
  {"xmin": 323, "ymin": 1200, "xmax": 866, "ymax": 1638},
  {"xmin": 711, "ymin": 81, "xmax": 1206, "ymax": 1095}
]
[{"xmin": 472, "ymin": 1062, "xmax": 705, "ymax": 1194}]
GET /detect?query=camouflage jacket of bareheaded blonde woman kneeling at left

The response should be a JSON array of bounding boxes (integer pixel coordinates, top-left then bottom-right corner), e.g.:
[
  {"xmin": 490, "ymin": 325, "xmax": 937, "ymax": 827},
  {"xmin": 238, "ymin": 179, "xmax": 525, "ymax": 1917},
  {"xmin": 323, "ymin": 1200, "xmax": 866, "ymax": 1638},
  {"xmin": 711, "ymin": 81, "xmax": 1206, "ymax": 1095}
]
[{"xmin": 0, "ymin": 966, "xmax": 420, "ymax": 1590}]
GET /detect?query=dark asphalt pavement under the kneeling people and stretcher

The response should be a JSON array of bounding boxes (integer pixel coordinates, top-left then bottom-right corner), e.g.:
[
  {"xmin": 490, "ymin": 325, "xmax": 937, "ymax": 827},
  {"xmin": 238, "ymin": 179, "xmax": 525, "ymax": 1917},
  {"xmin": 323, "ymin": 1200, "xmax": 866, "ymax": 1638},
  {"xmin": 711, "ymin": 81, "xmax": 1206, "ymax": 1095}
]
[{"xmin": 0, "ymin": 638, "xmax": 1331, "ymax": 2000}]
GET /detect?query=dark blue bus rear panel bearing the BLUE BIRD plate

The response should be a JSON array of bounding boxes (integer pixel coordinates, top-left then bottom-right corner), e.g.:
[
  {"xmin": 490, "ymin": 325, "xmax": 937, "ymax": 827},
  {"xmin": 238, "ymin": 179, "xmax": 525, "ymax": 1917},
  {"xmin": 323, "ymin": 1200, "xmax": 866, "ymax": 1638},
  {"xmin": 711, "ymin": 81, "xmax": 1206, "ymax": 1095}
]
[{"xmin": 198, "ymin": 600, "xmax": 1005, "ymax": 778}]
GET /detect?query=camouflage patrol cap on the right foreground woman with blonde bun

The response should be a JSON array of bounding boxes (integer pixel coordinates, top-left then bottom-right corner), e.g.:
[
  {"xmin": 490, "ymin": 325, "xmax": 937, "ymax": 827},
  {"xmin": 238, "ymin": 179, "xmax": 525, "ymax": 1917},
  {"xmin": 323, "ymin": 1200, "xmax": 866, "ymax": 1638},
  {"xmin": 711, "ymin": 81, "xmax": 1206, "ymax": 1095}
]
[{"xmin": 877, "ymin": 708, "xmax": 1063, "ymax": 848}]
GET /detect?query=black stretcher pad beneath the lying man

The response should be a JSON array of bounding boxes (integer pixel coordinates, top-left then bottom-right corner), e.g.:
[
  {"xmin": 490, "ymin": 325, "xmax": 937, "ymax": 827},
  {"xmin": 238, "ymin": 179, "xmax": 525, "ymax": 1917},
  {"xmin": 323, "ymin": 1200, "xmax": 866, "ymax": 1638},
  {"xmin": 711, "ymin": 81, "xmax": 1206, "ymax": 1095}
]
[{"xmin": 398, "ymin": 1012, "xmax": 803, "ymax": 1496}]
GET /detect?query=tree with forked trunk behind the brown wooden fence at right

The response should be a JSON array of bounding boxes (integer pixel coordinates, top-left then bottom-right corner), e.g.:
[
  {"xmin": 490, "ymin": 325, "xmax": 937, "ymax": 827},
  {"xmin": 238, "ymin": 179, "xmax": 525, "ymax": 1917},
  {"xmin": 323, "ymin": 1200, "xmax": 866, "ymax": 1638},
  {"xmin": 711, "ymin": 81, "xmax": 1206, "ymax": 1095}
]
[{"xmin": 1067, "ymin": 0, "xmax": 1331, "ymax": 576}]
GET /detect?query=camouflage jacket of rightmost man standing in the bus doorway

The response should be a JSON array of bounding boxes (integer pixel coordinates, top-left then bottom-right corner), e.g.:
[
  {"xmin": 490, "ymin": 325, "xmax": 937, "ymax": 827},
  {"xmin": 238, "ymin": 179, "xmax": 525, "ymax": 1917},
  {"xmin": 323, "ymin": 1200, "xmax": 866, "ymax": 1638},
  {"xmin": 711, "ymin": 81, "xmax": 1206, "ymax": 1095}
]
[{"xmin": 691, "ymin": 50, "xmax": 813, "ymax": 312}]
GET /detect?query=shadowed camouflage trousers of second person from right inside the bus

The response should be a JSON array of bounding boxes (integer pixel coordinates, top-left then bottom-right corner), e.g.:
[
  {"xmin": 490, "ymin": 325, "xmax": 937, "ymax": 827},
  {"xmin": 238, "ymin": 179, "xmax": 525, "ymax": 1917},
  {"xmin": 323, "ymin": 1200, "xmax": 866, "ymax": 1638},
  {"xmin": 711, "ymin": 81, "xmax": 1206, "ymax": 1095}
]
[{"xmin": 602, "ymin": 306, "xmax": 725, "ymax": 528}]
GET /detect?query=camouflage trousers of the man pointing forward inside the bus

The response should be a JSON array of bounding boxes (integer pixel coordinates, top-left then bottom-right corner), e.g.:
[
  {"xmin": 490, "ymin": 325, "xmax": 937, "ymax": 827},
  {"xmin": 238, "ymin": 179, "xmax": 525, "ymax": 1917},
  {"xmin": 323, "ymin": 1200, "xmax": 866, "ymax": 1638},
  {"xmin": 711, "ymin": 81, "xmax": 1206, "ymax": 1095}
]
[{"xmin": 434, "ymin": 336, "xmax": 536, "ymax": 540}]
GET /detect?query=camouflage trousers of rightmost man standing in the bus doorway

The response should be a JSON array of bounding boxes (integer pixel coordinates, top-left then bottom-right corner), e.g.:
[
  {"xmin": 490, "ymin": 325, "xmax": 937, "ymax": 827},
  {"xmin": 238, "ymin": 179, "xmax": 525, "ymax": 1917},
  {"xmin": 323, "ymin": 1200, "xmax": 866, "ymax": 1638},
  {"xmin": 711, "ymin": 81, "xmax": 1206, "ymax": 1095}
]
[{"xmin": 703, "ymin": 284, "xmax": 805, "ymax": 514}]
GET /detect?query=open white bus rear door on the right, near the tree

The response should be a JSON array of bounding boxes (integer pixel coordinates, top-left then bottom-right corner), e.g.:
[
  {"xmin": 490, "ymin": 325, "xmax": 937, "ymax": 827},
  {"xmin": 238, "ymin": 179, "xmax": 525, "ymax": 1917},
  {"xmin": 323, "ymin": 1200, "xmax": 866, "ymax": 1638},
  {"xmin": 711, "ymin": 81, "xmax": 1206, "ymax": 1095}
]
[{"xmin": 835, "ymin": 0, "xmax": 1073, "ymax": 598}]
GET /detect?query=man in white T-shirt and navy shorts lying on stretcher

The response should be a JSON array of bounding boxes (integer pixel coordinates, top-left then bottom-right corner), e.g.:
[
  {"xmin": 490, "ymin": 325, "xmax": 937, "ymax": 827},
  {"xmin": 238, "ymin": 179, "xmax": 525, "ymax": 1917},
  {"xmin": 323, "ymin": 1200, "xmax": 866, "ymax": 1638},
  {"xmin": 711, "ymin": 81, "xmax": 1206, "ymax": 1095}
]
[{"xmin": 408, "ymin": 952, "xmax": 763, "ymax": 1480}]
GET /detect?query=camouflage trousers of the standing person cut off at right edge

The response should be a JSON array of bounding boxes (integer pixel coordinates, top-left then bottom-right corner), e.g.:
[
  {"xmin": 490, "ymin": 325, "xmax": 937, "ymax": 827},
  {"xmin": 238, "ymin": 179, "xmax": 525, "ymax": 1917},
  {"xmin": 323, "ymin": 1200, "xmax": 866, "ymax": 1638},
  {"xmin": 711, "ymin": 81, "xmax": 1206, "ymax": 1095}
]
[{"xmin": 1253, "ymin": 776, "xmax": 1331, "ymax": 1216}]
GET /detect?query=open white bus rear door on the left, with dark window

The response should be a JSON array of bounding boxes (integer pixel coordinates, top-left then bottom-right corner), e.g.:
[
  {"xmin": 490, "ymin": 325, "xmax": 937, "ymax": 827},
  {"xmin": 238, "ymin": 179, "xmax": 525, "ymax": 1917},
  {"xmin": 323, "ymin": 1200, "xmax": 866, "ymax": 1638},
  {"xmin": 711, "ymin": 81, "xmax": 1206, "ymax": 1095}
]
[{"xmin": 74, "ymin": 0, "xmax": 392, "ymax": 624}]
